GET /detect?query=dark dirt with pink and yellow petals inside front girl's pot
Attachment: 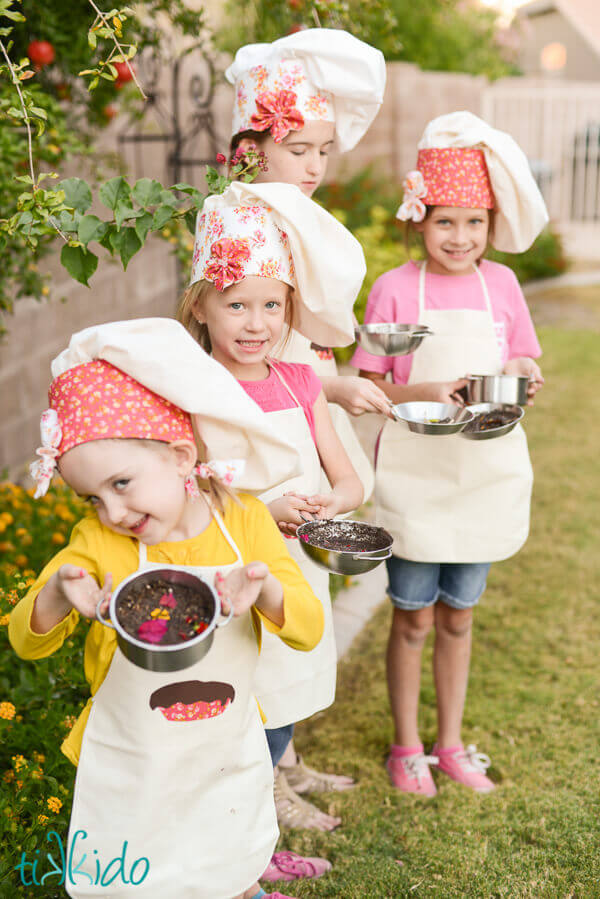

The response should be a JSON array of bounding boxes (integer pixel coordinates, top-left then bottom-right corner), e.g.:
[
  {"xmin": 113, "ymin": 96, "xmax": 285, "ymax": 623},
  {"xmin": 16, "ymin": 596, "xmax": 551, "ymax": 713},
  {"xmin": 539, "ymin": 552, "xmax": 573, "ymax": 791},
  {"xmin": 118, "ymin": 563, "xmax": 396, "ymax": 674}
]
[{"xmin": 116, "ymin": 577, "xmax": 214, "ymax": 646}]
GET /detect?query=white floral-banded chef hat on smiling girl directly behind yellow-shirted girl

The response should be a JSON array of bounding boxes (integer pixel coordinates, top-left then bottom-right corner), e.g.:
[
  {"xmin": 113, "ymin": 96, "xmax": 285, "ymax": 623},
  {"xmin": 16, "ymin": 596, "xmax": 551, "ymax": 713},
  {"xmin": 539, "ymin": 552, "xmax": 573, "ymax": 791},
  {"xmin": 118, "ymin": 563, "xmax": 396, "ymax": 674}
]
[{"xmin": 190, "ymin": 181, "xmax": 366, "ymax": 346}]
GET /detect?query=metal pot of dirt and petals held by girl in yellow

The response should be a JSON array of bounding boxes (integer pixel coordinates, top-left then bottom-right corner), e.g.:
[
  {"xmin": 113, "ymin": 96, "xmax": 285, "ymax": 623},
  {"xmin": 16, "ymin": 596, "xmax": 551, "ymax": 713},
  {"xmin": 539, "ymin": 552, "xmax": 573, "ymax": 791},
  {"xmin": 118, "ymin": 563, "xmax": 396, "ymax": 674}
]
[{"xmin": 96, "ymin": 566, "xmax": 233, "ymax": 671}]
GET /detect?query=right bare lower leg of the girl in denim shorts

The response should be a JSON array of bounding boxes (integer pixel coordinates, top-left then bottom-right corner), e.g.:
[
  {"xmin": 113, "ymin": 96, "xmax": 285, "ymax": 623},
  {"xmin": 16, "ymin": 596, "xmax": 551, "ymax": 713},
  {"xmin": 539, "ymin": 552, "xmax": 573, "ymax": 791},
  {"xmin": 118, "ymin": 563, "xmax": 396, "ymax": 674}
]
[{"xmin": 433, "ymin": 602, "xmax": 473, "ymax": 749}]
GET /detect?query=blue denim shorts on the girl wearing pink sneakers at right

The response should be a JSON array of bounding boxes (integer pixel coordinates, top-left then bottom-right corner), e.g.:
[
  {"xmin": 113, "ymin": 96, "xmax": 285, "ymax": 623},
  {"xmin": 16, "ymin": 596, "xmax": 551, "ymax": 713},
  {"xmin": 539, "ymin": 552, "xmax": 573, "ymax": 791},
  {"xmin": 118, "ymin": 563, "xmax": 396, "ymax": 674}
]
[{"xmin": 385, "ymin": 556, "xmax": 490, "ymax": 611}]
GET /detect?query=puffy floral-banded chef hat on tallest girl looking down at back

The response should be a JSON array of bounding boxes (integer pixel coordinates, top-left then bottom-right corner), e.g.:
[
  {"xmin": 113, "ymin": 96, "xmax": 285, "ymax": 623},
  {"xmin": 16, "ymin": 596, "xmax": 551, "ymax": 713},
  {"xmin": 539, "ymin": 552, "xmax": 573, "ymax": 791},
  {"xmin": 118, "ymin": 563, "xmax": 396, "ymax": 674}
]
[{"xmin": 225, "ymin": 28, "xmax": 385, "ymax": 152}]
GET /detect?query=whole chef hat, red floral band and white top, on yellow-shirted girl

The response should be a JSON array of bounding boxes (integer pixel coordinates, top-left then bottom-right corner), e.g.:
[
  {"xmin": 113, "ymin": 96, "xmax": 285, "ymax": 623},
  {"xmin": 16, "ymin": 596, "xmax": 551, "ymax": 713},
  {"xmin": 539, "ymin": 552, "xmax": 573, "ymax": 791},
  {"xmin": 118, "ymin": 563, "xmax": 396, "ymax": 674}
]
[{"xmin": 31, "ymin": 318, "xmax": 301, "ymax": 496}]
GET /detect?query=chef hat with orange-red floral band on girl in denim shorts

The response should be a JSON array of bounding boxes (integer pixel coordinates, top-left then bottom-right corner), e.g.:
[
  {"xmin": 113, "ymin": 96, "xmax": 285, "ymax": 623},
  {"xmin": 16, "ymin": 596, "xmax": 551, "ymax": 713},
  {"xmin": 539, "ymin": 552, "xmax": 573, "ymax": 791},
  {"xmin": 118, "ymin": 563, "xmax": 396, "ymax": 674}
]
[{"xmin": 397, "ymin": 112, "xmax": 548, "ymax": 253}]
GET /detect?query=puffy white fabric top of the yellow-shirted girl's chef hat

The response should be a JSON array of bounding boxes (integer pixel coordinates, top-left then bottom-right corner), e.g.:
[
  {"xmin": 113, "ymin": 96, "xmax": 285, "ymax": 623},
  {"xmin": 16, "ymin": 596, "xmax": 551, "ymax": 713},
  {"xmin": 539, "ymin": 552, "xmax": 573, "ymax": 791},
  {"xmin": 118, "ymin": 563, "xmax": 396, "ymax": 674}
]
[{"xmin": 51, "ymin": 318, "xmax": 301, "ymax": 492}]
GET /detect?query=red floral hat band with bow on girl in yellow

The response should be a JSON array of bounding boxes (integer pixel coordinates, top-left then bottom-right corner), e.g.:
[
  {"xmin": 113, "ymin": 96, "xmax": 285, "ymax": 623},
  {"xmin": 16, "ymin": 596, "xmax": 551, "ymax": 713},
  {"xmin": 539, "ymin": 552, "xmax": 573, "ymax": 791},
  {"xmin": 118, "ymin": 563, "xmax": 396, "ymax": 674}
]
[{"xmin": 30, "ymin": 359, "xmax": 194, "ymax": 497}]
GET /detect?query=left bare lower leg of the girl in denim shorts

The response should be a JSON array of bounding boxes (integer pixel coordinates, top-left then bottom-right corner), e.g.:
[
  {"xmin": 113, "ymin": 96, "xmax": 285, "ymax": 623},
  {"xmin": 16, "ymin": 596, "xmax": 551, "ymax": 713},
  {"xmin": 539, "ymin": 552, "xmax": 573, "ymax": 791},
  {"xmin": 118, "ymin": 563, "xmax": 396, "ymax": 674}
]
[{"xmin": 387, "ymin": 606, "xmax": 433, "ymax": 746}]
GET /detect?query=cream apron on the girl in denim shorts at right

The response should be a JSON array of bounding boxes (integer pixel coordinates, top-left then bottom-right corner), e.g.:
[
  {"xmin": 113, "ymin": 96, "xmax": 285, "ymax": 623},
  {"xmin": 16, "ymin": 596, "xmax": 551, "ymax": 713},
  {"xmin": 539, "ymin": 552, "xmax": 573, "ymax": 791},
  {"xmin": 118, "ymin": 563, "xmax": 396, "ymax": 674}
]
[{"xmin": 375, "ymin": 265, "xmax": 533, "ymax": 562}]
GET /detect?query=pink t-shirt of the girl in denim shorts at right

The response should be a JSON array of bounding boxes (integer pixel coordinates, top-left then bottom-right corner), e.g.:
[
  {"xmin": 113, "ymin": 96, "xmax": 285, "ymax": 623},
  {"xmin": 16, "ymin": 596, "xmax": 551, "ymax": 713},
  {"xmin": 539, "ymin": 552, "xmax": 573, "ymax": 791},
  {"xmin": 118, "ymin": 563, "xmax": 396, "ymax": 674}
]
[{"xmin": 351, "ymin": 259, "xmax": 542, "ymax": 384}]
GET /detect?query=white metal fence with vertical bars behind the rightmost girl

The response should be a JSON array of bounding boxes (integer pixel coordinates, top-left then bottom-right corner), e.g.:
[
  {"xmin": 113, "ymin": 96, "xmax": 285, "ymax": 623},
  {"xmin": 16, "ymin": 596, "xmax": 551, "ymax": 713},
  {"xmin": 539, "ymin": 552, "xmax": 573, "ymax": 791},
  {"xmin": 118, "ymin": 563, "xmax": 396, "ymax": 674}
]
[{"xmin": 482, "ymin": 79, "xmax": 600, "ymax": 222}]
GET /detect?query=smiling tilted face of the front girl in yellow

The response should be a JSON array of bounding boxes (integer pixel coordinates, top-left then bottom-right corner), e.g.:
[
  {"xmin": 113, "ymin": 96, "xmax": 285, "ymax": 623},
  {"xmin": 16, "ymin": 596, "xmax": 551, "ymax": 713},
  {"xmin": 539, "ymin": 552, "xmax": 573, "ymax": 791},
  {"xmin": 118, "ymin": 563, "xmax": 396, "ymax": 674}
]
[{"xmin": 59, "ymin": 440, "xmax": 206, "ymax": 545}]
